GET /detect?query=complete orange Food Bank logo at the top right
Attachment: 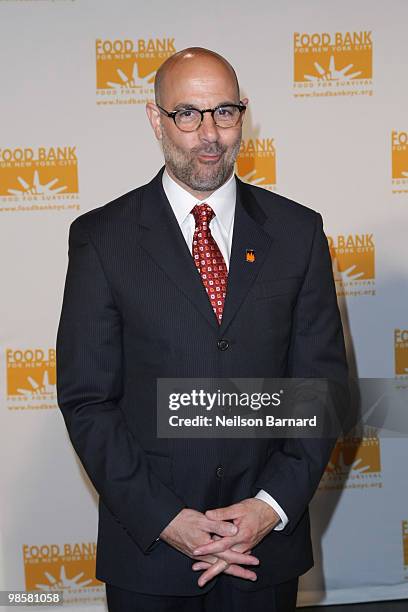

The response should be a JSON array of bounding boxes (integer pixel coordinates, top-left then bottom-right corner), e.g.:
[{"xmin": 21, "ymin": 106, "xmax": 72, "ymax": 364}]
[{"xmin": 293, "ymin": 30, "xmax": 373, "ymax": 97}]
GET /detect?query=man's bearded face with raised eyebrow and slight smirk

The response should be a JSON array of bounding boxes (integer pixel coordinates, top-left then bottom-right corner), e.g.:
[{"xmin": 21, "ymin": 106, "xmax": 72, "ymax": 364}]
[{"xmin": 148, "ymin": 58, "xmax": 247, "ymax": 193}]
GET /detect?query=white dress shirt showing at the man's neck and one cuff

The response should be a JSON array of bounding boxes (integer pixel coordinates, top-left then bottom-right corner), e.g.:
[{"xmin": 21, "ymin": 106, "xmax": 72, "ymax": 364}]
[{"xmin": 162, "ymin": 170, "xmax": 289, "ymax": 531}]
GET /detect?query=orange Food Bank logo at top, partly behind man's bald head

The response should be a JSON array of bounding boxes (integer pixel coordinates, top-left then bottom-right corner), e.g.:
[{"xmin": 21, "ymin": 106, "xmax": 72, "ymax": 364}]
[{"xmin": 96, "ymin": 38, "xmax": 176, "ymax": 104}]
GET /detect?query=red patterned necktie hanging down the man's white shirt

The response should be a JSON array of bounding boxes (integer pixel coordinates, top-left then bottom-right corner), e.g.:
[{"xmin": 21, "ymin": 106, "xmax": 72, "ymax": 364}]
[{"xmin": 191, "ymin": 203, "xmax": 228, "ymax": 325}]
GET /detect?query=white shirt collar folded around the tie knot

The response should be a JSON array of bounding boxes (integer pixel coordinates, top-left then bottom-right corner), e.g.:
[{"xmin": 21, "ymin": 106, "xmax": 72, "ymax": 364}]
[{"xmin": 162, "ymin": 169, "xmax": 237, "ymax": 232}]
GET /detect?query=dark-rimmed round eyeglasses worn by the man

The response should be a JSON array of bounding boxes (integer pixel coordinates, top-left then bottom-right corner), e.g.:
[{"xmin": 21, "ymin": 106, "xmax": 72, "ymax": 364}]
[{"xmin": 156, "ymin": 102, "xmax": 246, "ymax": 132}]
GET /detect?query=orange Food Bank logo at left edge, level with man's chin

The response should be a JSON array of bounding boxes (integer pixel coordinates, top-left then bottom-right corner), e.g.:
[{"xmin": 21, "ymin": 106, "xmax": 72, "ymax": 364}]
[{"xmin": 0, "ymin": 146, "xmax": 78, "ymax": 202}]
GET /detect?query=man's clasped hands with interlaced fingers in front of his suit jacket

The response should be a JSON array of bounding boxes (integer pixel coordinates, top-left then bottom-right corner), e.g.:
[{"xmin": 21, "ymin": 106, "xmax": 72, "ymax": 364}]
[{"xmin": 160, "ymin": 497, "xmax": 280, "ymax": 587}]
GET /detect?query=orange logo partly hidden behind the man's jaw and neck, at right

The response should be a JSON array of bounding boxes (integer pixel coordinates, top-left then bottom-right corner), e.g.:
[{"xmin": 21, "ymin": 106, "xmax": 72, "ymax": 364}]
[{"xmin": 237, "ymin": 138, "xmax": 276, "ymax": 190}]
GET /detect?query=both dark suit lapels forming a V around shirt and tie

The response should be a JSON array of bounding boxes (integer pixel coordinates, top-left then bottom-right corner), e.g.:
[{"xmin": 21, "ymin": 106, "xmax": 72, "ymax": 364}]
[{"xmin": 139, "ymin": 168, "xmax": 272, "ymax": 335}]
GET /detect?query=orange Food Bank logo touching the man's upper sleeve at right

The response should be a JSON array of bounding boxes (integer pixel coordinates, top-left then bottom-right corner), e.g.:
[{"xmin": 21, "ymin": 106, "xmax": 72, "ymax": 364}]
[{"xmin": 327, "ymin": 234, "xmax": 375, "ymax": 295}]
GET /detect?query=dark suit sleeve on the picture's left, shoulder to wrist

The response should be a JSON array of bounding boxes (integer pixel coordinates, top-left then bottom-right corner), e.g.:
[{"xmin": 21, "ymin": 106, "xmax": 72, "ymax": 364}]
[{"xmin": 57, "ymin": 218, "xmax": 185, "ymax": 554}]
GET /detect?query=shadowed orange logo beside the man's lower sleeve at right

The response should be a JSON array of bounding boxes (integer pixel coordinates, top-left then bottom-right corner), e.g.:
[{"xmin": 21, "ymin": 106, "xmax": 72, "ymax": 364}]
[{"xmin": 321, "ymin": 429, "xmax": 382, "ymax": 488}]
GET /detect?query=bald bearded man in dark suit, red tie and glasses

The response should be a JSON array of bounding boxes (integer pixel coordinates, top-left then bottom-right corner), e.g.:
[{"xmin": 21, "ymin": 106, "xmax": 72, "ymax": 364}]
[{"xmin": 57, "ymin": 48, "xmax": 347, "ymax": 612}]
